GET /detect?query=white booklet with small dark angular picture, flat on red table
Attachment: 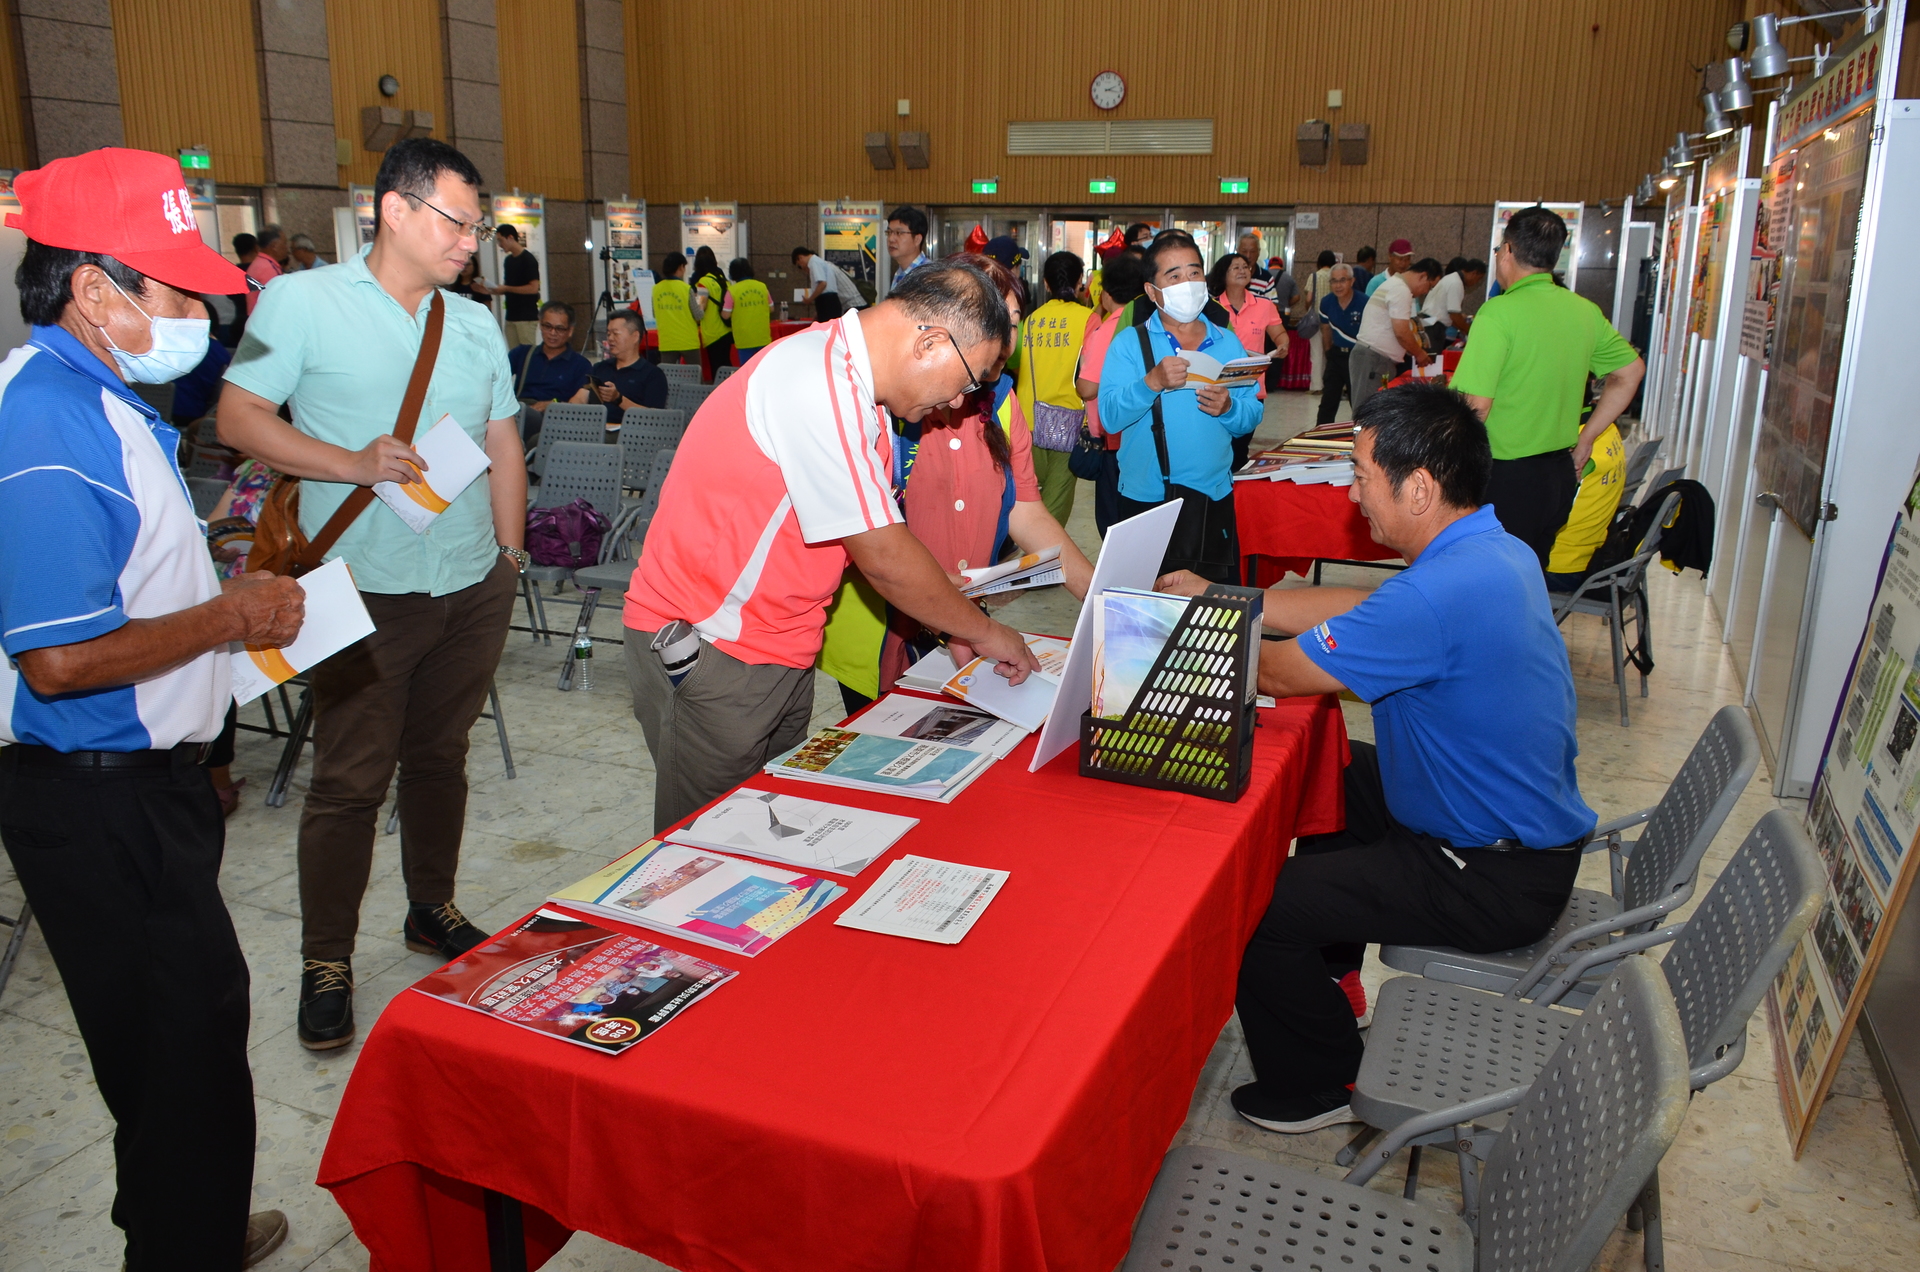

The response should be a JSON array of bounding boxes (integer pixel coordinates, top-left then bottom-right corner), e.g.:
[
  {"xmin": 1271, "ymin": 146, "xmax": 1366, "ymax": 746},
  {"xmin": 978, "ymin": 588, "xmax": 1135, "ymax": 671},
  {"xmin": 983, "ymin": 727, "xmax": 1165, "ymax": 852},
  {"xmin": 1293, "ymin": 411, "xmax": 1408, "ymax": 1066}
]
[{"xmin": 666, "ymin": 787, "xmax": 910, "ymax": 874}]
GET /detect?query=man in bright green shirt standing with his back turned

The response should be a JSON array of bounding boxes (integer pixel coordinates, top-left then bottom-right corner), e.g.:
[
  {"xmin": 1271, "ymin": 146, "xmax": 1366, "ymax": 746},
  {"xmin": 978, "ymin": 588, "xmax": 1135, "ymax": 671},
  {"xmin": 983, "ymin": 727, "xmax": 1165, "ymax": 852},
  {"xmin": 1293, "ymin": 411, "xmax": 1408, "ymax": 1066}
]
[{"xmin": 1453, "ymin": 206, "xmax": 1647, "ymax": 569}]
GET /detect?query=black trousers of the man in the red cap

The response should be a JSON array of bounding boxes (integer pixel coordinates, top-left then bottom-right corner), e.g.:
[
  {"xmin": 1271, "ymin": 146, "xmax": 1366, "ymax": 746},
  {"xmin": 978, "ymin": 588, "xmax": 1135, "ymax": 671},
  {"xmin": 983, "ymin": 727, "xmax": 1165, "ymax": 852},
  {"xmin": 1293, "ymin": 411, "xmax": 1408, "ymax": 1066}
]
[{"xmin": 0, "ymin": 747, "xmax": 253, "ymax": 1272}]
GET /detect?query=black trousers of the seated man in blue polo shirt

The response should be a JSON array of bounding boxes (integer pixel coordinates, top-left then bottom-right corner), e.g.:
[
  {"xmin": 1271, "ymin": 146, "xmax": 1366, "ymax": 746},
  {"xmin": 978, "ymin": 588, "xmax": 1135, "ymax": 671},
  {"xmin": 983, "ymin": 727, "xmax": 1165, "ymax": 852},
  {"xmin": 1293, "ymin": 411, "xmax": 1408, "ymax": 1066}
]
[{"xmin": 1235, "ymin": 742, "xmax": 1580, "ymax": 1097}]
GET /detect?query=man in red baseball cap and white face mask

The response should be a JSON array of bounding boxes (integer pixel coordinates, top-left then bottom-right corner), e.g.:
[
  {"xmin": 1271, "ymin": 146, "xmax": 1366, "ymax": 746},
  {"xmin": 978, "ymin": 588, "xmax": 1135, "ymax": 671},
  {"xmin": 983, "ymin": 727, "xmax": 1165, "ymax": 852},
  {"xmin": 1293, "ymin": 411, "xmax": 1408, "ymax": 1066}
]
[{"xmin": 0, "ymin": 148, "xmax": 303, "ymax": 1270}]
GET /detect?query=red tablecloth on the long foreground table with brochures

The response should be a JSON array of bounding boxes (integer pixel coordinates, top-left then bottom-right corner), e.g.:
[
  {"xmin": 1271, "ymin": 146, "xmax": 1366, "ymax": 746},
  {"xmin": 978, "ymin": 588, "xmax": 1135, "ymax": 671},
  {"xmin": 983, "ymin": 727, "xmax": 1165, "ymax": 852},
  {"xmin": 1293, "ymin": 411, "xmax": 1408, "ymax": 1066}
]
[{"xmin": 319, "ymin": 697, "xmax": 1348, "ymax": 1272}]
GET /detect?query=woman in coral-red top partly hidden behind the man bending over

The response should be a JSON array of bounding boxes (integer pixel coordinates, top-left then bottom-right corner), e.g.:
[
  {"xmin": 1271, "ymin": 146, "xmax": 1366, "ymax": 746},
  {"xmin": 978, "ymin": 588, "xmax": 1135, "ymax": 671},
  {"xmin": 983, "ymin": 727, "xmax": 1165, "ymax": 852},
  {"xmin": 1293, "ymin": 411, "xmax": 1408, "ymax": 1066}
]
[{"xmin": 818, "ymin": 256, "xmax": 1092, "ymax": 711}]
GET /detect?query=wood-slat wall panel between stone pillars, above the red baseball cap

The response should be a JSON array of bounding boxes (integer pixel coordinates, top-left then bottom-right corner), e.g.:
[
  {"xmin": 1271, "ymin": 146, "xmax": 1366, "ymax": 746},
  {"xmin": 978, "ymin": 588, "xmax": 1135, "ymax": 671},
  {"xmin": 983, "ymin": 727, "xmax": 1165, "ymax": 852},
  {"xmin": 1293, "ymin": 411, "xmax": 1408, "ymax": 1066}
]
[{"xmin": 110, "ymin": 0, "xmax": 267, "ymax": 186}]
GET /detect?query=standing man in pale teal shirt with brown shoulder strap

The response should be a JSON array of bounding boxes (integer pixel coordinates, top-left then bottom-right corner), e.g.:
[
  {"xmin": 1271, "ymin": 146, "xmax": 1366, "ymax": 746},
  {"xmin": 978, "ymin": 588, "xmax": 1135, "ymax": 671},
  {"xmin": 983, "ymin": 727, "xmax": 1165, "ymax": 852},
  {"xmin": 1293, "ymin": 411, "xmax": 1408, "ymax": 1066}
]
[{"xmin": 219, "ymin": 138, "xmax": 526, "ymax": 1051}]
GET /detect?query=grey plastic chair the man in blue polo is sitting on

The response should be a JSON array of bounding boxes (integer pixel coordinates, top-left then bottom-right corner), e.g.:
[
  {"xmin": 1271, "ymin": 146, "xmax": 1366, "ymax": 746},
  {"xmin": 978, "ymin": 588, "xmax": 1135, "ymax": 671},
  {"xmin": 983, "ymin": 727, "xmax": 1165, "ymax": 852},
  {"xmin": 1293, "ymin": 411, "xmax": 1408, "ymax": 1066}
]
[{"xmin": 1380, "ymin": 707, "xmax": 1761, "ymax": 1005}]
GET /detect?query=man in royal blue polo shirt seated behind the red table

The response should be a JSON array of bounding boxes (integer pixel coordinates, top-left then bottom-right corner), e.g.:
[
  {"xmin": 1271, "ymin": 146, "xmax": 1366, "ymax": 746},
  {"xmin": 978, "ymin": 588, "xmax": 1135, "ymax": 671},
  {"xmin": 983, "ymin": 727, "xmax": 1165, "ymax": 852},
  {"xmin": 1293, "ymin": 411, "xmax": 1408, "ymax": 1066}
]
[{"xmin": 1160, "ymin": 386, "xmax": 1596, "ymax": 1132}]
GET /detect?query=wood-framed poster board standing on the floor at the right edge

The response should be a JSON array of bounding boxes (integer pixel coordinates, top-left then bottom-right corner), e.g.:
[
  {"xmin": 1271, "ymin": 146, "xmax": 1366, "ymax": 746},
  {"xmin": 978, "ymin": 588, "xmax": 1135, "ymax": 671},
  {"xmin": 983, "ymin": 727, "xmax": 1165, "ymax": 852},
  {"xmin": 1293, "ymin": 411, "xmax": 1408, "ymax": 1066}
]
[{"xmin": 1766, "ymin": 459, "xmax": 1920, "ymax": 1157}]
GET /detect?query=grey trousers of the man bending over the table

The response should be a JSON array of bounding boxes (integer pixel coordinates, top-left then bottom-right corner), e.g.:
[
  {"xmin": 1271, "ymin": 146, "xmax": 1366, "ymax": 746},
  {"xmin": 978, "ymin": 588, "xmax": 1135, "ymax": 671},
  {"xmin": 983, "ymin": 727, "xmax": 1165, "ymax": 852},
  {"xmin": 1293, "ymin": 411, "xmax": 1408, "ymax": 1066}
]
[{"xmin": 626, "ymin": 628, "xmax": 814, "ymax": 834}]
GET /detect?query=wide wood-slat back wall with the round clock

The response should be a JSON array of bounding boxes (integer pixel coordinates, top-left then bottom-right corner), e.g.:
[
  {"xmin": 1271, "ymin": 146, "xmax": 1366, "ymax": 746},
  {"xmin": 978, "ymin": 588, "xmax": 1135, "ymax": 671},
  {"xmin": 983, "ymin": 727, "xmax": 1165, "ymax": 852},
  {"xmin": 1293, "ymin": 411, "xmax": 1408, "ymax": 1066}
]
[{"xmin": 626, "ymin": 0, "xmax": 1751, "ymax": 206}]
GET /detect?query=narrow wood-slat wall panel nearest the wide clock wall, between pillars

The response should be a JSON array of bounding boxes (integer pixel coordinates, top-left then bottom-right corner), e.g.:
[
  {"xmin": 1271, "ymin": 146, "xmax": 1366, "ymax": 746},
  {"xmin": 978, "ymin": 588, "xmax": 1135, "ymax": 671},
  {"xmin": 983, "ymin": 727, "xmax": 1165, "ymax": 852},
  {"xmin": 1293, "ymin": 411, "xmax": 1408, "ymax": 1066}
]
[{"xmin": 493, "ymin": 0, "xmax": 588, "ymax": 200}]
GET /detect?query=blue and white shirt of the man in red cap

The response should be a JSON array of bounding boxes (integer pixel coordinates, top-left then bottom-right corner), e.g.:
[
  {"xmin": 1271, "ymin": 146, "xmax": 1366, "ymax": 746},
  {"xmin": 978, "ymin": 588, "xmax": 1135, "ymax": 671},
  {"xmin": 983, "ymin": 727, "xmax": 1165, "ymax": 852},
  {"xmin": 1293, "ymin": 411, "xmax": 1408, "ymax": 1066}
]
[{"xmin": 0, "ymin": 327, "xmax": 232, "ymax": 751}]
